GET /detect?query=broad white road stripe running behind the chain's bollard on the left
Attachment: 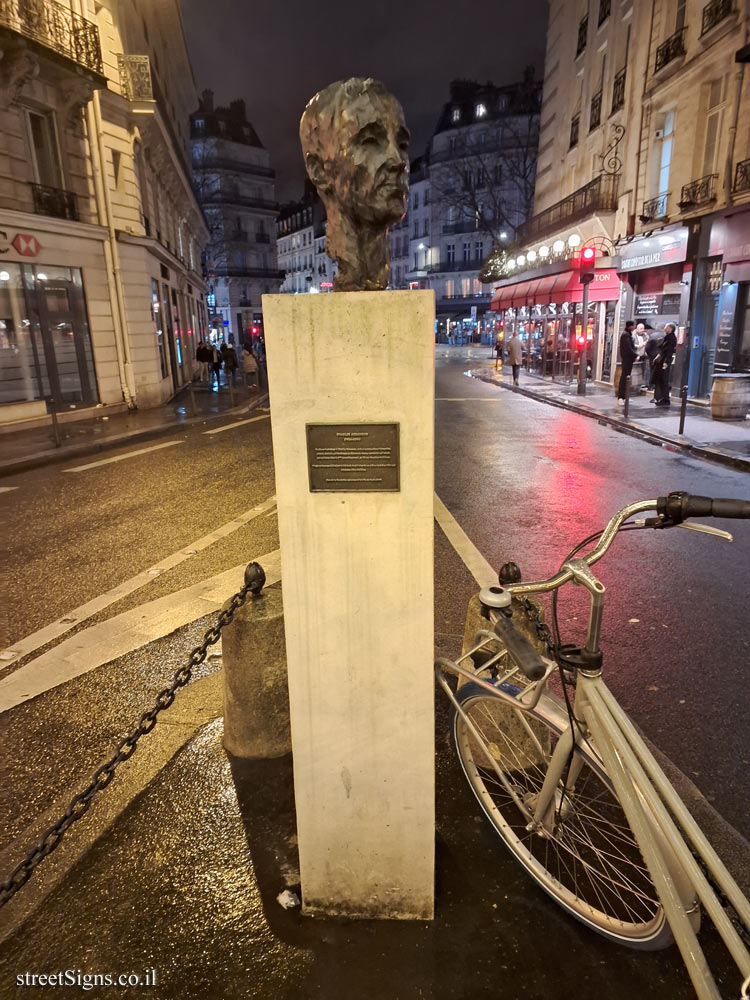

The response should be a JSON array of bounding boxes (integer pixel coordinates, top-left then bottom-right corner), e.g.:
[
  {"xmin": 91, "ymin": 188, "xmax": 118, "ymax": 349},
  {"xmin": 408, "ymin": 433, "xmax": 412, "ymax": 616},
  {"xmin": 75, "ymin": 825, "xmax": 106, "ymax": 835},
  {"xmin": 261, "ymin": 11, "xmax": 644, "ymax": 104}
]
[{"xmin": 0, "ymin": 549, "xmax": 281, "ymax": 713}]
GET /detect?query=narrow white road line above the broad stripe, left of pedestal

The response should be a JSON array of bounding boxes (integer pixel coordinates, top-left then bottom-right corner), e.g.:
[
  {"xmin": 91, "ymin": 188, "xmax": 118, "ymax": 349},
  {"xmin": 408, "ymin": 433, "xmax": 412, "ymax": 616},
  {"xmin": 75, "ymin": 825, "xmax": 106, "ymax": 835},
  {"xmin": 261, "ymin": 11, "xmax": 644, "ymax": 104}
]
[{"xmin": 0, "ymin": 496, "xmax": 276, "ymax": 667}]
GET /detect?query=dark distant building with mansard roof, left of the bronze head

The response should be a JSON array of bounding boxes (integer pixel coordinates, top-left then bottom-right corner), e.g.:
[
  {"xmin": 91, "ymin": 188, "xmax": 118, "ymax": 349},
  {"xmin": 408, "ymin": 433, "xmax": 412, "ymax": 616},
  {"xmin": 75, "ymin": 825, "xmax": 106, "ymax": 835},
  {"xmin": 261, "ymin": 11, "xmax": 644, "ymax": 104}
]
[{"xmin": 190, "ymin": 90, "xmax": 282, "ymax": 345}]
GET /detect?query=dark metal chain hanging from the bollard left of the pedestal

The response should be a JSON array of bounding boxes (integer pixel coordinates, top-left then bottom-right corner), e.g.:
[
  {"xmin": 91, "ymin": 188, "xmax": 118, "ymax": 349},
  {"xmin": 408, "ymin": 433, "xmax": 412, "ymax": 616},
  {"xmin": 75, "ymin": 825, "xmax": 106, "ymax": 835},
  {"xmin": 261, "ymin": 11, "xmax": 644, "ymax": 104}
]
[{"xmin": 0, "ymin": 562, "xmax": 266, "ymax": 908}]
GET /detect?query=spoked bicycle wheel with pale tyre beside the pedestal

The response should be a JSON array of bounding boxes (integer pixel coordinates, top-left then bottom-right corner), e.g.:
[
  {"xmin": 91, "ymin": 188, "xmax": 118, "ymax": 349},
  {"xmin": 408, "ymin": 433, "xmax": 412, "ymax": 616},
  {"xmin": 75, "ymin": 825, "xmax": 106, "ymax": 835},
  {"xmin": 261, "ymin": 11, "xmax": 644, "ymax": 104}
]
[{"xmin": 451, "ymin": 683, "xmax": 672, "ymax": 950}]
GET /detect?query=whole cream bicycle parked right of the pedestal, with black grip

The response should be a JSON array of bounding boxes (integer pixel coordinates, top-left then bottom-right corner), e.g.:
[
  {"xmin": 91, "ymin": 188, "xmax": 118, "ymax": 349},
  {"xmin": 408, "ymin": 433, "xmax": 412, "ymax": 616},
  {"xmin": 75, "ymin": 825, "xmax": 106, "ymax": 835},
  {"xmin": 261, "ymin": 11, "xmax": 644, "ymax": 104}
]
[{"xmin": 435, "ymin": 493, "xmax": 750, "ymax": 1000}]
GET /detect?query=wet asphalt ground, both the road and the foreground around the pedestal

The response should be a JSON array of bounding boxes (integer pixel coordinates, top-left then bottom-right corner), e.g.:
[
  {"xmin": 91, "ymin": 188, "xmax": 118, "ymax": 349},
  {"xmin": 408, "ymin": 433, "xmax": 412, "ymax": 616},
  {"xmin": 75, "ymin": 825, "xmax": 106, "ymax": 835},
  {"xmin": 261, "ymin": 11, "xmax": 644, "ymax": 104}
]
[{"xmin": 0, "ymin": 348, "xmax": 750, "ymax": 1000}]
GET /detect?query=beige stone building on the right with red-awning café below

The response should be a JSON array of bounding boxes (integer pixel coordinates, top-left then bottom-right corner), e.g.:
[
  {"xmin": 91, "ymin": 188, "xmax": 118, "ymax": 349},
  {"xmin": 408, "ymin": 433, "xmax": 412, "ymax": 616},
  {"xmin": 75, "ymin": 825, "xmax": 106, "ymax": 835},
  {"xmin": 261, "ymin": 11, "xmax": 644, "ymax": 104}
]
[{"xmin": 493, "ymin": 0, "xmax": 750, "ymax": 397}]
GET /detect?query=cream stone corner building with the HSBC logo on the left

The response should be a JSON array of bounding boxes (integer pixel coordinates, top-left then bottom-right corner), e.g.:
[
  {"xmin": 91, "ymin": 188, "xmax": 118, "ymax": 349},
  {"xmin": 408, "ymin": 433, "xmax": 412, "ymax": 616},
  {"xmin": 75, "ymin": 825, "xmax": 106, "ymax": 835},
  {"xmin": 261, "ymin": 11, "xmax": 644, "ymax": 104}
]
[{"xmin": 0, "ymin": 0, "xmax": 212, "ymax": 425}]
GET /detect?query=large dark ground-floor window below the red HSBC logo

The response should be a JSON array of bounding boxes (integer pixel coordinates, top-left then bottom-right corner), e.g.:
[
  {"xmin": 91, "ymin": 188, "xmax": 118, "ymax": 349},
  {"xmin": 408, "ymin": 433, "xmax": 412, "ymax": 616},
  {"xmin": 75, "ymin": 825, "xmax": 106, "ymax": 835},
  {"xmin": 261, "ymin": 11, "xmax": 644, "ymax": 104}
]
[{"xmin": 0, "ymin": 263, "xmax": 98, "ymax": 409}]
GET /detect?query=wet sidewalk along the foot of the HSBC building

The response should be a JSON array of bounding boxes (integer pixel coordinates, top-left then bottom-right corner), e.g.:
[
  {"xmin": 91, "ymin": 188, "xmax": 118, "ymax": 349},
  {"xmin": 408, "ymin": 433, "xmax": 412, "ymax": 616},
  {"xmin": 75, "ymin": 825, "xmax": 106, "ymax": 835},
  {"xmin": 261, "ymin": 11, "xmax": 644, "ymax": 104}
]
[{"xmin": 0, "ymin": 377, "xmax": 268, "ymax": 477}]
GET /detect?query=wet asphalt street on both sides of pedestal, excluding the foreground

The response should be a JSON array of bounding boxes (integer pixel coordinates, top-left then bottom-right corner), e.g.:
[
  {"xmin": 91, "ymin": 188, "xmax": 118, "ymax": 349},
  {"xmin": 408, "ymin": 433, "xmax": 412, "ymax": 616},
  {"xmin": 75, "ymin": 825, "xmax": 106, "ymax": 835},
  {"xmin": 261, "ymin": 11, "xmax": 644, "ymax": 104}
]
[{"xmin": 0, "ymin": 348, "xmax": 750, "ymax": 836}]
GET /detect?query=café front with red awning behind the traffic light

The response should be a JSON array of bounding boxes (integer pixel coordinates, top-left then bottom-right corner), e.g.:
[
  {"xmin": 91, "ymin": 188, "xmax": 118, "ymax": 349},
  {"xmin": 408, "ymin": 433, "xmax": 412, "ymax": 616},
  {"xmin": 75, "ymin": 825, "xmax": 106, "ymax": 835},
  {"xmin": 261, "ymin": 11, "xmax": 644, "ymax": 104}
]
[{"xmin": 490, "ymin": 267, "xmax": 620, "ymax": 379}]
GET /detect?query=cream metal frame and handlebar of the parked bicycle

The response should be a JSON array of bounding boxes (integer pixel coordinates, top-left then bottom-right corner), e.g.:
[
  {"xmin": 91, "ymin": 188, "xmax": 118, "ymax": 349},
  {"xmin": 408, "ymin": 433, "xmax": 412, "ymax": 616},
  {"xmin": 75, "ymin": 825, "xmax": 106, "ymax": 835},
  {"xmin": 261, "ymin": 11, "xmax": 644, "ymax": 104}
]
[{"xmin": 437, "ymin": 500, "xmax": 750, "ymax": 1000}]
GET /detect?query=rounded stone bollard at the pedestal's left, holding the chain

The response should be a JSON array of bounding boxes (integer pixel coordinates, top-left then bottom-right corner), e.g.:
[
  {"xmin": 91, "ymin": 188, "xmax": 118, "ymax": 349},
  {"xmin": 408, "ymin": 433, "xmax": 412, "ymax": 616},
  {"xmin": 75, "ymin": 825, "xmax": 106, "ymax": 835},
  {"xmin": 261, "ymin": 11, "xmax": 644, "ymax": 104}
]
[{"xmin": 222, "ymin": 587, "xmax": 292, "ymax": 758}]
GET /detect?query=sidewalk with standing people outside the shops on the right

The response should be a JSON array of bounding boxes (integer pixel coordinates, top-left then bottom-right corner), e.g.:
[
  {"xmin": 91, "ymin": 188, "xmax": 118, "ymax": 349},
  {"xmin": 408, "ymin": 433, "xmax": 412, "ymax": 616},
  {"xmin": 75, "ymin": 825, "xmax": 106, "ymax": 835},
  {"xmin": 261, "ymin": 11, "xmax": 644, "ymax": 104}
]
[{"xmin": 470, "ymin": 348, "xmax": 750, "ymax": 472}]
